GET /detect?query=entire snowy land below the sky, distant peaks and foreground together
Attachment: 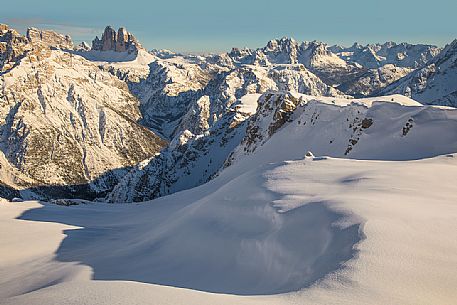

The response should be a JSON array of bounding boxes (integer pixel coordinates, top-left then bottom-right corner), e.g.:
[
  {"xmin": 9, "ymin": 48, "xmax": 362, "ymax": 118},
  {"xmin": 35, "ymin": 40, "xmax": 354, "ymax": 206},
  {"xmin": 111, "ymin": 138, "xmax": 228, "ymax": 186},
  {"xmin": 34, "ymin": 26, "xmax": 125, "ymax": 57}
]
[{"xmin": 0, "ymin": 24, "xmax": 457, "ymax": 304}]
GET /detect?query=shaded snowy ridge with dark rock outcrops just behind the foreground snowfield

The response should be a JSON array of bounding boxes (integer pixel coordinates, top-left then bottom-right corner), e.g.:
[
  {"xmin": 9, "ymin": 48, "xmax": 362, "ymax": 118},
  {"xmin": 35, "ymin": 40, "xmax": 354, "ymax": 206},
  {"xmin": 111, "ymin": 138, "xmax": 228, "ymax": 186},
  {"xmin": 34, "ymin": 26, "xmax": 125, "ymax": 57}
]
[{"xmin": 232, "ymin": 93, "xmax": 457, "ymax": 164}]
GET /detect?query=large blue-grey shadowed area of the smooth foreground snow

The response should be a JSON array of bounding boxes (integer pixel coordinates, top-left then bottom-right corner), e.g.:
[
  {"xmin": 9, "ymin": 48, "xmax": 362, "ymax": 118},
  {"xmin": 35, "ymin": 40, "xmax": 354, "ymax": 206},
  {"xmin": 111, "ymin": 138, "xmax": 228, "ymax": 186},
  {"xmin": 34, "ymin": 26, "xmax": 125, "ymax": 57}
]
[{"xmin": 14, "ymin": 159, "xmax": 361, "ymax": 295}]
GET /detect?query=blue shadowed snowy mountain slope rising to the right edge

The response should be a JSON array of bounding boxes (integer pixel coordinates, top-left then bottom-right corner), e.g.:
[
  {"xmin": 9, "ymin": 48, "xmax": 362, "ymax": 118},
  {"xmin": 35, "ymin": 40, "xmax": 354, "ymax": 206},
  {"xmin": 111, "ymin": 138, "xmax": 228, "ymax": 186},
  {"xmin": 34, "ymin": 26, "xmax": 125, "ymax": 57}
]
[{"xmin": 381, "ymin": 40, "xmax": 457, "ymax": 107}]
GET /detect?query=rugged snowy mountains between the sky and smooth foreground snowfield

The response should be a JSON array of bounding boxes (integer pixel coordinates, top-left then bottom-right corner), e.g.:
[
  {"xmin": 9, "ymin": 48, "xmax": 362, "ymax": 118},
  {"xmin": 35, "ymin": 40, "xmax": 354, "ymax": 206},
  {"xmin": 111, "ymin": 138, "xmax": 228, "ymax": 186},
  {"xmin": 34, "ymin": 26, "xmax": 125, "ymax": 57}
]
[{"xmin": 0, "ymin": 25, "xmax": 457, "ymax": 202}]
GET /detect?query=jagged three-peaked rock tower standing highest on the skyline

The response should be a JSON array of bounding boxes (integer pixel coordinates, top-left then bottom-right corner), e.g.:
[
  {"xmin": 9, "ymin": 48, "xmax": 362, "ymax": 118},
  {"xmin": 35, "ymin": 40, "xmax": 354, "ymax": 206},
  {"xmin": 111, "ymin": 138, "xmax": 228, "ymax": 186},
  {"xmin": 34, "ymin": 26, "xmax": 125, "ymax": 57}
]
[{"xmin": 92, "ymin": 26, "xmax": 141, "ymax": 52}]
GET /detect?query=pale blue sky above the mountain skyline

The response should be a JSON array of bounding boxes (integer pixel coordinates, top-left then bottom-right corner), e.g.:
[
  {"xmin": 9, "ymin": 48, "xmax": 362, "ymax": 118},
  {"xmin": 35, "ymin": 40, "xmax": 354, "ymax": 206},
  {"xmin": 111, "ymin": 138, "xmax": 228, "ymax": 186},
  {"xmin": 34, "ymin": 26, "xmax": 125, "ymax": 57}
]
[{"xmin": 0, "ymin": 0, "xmax": 457, "ymax": 52}]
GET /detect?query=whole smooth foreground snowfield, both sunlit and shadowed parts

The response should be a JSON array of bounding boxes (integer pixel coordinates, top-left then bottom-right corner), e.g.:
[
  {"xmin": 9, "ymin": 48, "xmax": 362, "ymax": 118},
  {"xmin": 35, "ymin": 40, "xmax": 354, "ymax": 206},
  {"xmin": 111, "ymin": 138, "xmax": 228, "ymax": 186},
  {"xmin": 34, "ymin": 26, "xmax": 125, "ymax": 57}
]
[{"xmin": 0, "ymin": 154, "xmax": 457, "ymax": 304}]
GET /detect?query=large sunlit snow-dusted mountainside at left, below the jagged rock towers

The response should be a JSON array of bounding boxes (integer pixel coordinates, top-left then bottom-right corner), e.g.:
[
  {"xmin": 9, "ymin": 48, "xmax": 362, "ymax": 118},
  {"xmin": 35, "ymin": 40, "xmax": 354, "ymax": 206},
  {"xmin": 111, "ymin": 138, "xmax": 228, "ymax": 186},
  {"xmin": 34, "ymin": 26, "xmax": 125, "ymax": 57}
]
[{"xmin": 0, "ymin": 50, "xmax": 165, "ymax": 199}]
